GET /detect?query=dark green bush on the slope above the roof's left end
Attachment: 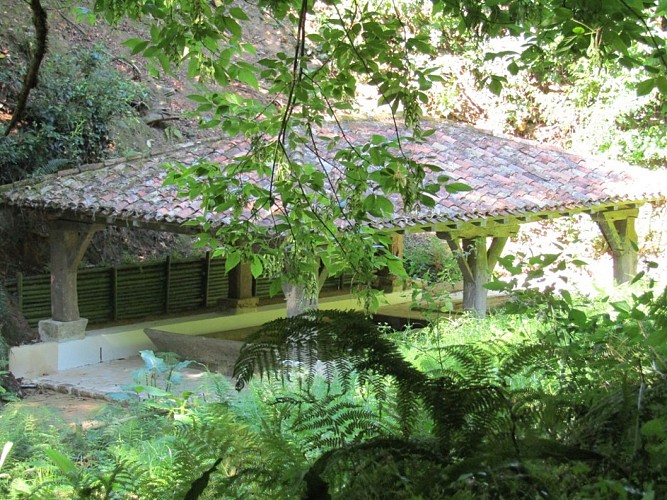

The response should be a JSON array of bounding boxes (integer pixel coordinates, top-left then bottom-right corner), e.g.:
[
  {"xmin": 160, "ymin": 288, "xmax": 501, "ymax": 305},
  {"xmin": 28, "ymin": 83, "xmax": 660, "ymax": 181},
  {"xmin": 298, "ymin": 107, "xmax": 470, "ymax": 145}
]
[{"xmin": 0, "ymin": 46, "xmax": 145, "ymax": 184}]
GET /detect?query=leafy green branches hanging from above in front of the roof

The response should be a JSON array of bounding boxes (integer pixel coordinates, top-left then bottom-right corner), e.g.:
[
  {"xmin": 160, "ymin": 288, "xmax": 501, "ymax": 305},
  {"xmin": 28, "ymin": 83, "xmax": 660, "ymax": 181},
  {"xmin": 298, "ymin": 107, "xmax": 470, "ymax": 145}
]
[{"xmin": 86, "ymin": 0, "xmax": 667, "ymax": 306}]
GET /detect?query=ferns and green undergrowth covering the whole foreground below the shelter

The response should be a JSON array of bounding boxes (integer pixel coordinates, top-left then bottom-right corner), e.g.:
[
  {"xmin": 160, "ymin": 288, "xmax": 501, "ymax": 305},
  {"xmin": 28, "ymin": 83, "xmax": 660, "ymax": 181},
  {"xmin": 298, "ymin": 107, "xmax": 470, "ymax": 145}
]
[{"xmin": 0, "ymin": 272, "xmax": 667, "ymax": 499}]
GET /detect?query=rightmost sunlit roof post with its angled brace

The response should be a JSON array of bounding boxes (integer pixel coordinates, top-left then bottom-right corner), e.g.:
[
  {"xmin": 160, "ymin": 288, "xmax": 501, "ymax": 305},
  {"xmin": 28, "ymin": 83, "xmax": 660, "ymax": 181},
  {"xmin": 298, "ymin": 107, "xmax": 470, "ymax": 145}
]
[{"xmin": 592, "ymin": 208, "xmax": 639, "ymax": 283}]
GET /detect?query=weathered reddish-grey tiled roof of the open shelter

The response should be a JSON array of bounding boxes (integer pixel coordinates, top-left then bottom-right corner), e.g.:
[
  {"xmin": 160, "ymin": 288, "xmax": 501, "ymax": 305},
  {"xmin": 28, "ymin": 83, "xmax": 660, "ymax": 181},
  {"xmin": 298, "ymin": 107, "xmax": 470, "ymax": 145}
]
[{"xmin": 0, "ymin": 122, "xmax": 667, "ymax": 232}]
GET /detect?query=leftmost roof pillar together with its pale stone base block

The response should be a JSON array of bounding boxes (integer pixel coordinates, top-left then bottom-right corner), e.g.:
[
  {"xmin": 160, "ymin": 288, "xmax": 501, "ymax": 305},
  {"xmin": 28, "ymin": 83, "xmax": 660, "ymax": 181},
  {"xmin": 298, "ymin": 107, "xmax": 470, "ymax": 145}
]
[{"xmin": 38, "ymin": 221, "xmax": 101, "ymax": 342}]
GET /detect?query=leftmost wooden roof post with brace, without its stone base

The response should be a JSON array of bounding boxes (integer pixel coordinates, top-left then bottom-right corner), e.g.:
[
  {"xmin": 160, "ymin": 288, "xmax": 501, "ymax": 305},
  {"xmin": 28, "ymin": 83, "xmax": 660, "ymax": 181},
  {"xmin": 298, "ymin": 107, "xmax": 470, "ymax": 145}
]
[{"xmin": 49, "ymin": 221, "xmax": 102, "ymax": 322}]
